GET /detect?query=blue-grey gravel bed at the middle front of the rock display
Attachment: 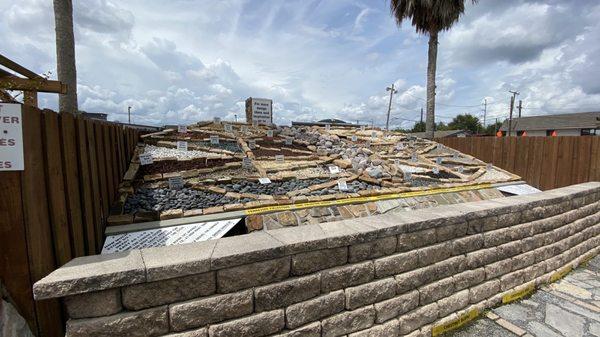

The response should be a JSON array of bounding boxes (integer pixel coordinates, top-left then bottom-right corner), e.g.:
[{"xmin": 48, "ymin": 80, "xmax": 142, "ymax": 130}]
[{"xmin": 220, "ymin": 179, "xmax": 328, "ymax": 195}]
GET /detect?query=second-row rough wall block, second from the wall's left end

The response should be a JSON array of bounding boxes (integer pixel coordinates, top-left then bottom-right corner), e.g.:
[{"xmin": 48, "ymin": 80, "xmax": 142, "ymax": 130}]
[{"xmin": 169, "ymin": 290, "xmax": 254, "ymax": 331}]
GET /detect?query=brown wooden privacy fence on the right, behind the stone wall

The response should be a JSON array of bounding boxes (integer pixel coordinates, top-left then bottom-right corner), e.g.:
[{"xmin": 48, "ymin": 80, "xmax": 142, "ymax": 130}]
[{"xmin": 436, "ymin": 136, "xmax": 600, "ymax": 190}]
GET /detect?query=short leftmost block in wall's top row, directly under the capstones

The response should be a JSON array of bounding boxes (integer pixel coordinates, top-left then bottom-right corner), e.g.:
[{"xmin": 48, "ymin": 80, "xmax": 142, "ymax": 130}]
[{"xmin": 65, "ymin": 289, "xmax": 123, "ymax": 318}]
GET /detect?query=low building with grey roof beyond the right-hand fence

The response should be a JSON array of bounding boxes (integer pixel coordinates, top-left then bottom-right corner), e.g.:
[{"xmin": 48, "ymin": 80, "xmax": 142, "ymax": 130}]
[{"xmin": 500, "ymin": 112, "xmax": 600, "ymax": 137}]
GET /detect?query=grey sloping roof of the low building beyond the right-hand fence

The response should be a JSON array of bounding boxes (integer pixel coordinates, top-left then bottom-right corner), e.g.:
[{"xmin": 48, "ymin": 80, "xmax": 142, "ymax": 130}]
[{"xmin": 500, "ymin": 112, "xmax": 600, "ymax": 131}]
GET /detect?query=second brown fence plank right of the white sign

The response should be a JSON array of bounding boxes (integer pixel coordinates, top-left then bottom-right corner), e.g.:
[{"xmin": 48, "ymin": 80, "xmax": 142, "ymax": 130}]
[{"xmin": 44, "ymin": 110, "xmax": 73, "ymax": 266}]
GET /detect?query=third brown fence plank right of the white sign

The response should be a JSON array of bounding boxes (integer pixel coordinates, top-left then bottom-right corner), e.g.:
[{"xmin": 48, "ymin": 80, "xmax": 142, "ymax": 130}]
[{"xmin": 60, "ymin": 112, "xmax": 86, "ymax": 257}]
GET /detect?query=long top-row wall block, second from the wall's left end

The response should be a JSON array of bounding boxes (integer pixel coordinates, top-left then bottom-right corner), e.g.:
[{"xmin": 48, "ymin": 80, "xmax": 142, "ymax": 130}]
[{"xmin": 122, "ymin": 272, "xmax": 216, "ymax": 310}]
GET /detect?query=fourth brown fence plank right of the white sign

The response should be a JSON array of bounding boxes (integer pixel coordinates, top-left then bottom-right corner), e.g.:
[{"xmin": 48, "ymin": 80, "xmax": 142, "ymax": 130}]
[{"xmin": 75, "ymin": 116, "xmax": 97, "ymax": 255}]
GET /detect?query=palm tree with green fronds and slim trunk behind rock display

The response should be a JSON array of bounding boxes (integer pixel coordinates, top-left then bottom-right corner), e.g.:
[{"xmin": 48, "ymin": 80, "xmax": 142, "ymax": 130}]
[{"xmin": 390, "ymin": 0, "xmax": 478, "ymax": 138}]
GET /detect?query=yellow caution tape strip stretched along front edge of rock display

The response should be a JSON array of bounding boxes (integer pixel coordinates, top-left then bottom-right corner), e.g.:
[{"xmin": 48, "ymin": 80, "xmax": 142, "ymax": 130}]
[{"xmin": 244, "ymin": 183, "xmax": 492, "ymax": 215}]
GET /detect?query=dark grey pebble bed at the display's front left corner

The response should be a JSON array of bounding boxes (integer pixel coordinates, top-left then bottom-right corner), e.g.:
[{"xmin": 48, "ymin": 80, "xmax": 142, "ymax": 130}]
[{"xmin": 124, "ymin": 187, "xmax": 251, "ymax": 213}]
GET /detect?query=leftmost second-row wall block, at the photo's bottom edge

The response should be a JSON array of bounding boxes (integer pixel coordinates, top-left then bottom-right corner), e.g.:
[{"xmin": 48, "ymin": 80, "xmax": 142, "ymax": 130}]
[{"xmin": 66, "ymin": 306, "xmax": 169, "ymax": 337}]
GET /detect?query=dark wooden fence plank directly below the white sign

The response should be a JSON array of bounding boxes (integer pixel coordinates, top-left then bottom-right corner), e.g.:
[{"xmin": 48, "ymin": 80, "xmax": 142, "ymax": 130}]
[{"xmin": 0, "ymin": 172, "xmax": 37, "ymax": 331}]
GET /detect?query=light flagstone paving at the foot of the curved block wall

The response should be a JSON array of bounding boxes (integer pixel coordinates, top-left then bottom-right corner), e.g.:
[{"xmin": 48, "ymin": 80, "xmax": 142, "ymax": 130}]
[{"xmin": 449, "ymin": 256, "xmax": 600, "ymax": 337}]
